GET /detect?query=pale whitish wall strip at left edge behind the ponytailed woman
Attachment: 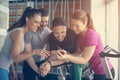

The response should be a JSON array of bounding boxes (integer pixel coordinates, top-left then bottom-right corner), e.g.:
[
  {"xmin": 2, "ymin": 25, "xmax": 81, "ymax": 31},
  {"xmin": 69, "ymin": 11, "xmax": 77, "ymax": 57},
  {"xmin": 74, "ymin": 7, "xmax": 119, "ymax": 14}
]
[{"xmin": 0, "ymin": 0, "xmax": 9, "ymax": 49}]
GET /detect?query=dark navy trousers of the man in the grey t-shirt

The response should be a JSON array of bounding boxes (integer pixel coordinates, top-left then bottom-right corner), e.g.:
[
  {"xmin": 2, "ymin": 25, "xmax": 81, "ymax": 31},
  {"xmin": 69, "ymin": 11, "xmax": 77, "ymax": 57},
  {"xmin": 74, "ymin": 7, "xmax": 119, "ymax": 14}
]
[{"xmin": 23, "ymin": 61, "xmax": 58, "ymax": 80}]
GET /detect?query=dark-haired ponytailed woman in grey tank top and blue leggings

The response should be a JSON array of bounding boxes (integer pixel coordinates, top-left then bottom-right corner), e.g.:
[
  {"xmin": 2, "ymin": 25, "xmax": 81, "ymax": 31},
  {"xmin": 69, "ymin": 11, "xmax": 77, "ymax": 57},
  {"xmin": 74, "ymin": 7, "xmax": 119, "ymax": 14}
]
[{"xmin": 0, "ymin": 7, "xmax": 47, "ymax": 80}]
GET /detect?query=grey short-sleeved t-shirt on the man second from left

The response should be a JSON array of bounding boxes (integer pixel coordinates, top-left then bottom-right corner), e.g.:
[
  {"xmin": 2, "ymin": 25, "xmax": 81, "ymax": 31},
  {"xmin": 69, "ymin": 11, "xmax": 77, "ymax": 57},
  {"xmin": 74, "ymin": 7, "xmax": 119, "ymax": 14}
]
[{"xmin": 25, "ymin": 27, "xmax": 51, "ymax": 62}]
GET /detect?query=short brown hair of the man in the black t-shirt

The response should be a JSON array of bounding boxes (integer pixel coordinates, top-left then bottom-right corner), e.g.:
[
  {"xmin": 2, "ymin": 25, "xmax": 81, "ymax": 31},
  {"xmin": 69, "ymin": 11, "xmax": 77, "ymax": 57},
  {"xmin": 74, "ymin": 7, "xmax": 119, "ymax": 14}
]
[{"xmin": 52, "ymin": 17, "xmax": 67, "ymax": 28}]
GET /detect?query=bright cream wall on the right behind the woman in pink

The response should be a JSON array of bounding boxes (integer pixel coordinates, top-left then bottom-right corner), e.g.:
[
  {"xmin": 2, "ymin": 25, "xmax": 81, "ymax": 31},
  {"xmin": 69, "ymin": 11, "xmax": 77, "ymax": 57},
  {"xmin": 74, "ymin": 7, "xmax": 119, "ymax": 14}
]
[{"xmin": 91, "ymin": 0, "xmax": 118, "ymax": 80}]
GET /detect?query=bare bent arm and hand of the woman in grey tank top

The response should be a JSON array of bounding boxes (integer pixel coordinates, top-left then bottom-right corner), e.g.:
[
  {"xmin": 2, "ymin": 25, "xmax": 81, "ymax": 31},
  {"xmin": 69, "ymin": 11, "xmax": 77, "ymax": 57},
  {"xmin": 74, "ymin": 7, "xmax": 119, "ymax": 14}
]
[{"xmin": 11, "ymin": 30, "xmax": 50, "ymax": 62}]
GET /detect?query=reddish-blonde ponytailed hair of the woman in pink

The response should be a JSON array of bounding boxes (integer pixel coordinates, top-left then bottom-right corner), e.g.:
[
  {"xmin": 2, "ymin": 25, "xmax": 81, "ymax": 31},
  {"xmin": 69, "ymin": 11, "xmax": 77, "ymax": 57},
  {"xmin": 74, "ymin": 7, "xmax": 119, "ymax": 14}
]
[{"xmin": 71, "ymin": 10, "xmax": 95, "ymax": 30}]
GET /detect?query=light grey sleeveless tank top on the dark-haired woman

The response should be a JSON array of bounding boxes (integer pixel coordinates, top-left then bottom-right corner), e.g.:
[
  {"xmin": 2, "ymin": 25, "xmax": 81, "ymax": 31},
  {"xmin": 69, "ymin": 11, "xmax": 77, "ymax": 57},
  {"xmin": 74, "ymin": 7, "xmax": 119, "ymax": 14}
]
[{"xmin": 0, "ymin": 28, "xmax": 24, "ymax": 71}]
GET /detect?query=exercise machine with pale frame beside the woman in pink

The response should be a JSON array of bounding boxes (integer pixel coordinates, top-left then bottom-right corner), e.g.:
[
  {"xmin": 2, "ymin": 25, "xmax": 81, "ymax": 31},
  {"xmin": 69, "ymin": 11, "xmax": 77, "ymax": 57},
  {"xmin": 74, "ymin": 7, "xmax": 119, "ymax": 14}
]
[{"xmin": 100, "ymin": 46, "xmax": 120, "ymax": 80}]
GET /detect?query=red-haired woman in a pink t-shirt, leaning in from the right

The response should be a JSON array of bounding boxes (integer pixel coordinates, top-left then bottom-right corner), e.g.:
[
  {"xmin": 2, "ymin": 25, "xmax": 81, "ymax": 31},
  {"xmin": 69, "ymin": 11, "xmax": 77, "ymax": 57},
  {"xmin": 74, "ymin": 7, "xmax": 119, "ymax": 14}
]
[{"xmin": 55, "ymin": 10, "xmax": 115, "ymax": 80}]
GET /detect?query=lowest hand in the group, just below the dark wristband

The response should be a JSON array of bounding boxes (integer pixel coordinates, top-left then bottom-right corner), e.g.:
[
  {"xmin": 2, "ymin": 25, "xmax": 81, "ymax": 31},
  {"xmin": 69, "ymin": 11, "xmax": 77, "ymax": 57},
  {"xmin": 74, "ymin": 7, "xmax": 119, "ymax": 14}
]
[{"xmin": 39, "ymin": 62, "xmax": 51, "ymax": 76}]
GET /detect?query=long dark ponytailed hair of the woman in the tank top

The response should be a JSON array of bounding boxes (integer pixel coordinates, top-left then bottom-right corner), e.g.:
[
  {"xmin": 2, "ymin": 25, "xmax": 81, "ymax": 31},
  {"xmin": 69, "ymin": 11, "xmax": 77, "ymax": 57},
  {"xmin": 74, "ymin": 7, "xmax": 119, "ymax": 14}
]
[{"xmin": 8, "ymin": 7, "xmax": 41, "ymax": 31}]
